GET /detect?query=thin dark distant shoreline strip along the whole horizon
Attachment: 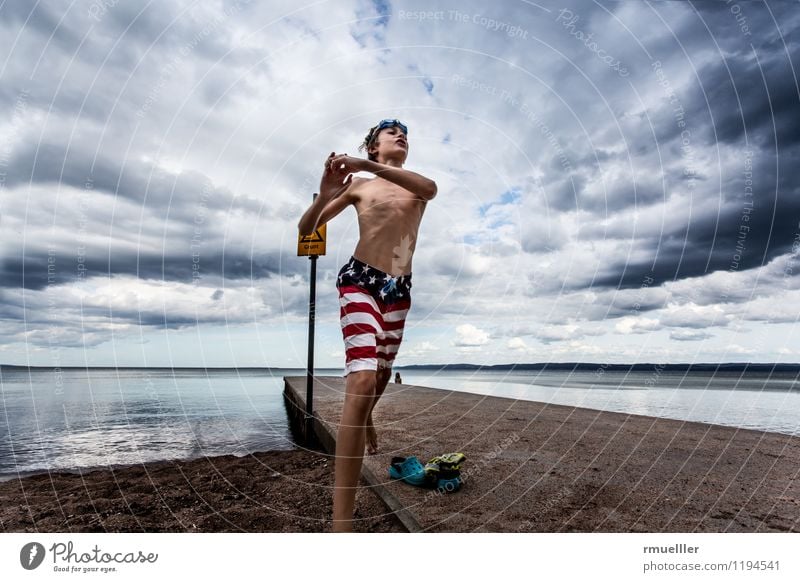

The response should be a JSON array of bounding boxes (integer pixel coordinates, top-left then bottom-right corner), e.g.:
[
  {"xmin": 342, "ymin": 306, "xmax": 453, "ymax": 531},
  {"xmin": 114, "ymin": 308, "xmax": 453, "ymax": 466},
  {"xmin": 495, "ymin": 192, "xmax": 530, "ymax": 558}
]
[{"xmin": 0, "ymin": 362, "xmax": 800, "ymax": 373}]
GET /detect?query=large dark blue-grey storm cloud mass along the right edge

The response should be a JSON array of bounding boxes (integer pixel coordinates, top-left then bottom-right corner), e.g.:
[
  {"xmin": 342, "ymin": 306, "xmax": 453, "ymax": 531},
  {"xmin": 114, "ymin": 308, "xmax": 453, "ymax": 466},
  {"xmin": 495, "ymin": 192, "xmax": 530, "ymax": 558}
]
[{"xmin": 593, "ymin": 3, "xmax": 800, "ymax": 288}]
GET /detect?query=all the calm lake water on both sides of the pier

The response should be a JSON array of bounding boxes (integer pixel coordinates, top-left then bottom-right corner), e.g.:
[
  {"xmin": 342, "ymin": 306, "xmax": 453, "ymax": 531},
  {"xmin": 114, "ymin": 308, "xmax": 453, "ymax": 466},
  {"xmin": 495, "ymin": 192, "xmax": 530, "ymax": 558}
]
[{"xmin": 0, "ymin": 368, "xmax": 800, "ymax": 479}]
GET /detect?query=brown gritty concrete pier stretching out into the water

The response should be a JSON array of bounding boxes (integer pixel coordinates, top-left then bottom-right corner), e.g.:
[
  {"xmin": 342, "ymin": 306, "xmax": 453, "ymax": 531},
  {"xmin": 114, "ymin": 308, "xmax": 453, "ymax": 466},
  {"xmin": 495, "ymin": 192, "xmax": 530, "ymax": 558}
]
[{"xmin": 285, "ymin": 377, "xmax": 800, "ymax": 532}]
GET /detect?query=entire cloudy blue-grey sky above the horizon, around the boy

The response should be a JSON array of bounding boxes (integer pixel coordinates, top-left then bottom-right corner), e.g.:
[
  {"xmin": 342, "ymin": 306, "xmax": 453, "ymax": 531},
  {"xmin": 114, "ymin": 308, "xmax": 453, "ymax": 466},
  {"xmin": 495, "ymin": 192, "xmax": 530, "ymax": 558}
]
[{"xmin": 0, "ymin": 0, "xmax": 800, "ymax": 367}]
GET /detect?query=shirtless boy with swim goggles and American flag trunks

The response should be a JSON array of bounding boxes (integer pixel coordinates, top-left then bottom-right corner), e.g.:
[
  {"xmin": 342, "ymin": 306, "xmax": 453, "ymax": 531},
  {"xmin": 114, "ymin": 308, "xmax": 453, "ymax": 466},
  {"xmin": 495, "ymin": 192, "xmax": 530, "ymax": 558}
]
[{"xmin": 298, "ymin": 119, "xmax": 436, "ymax": 531}]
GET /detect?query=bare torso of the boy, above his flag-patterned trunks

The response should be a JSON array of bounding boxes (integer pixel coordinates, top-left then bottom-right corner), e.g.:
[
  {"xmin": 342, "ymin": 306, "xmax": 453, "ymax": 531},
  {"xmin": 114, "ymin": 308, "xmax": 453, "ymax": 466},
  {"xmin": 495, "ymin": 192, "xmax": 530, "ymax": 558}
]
[{"xmin": 350, "ymin": 178, "xmax": 426, "ymax": 276}]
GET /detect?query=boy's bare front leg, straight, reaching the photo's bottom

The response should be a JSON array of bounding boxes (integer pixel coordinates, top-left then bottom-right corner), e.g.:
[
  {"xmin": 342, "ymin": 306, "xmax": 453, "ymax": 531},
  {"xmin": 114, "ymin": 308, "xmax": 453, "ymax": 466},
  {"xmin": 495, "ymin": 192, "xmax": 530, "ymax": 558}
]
[{"xmin": 333, "ymin": 370, "xmax": 376, "ymax": 532}]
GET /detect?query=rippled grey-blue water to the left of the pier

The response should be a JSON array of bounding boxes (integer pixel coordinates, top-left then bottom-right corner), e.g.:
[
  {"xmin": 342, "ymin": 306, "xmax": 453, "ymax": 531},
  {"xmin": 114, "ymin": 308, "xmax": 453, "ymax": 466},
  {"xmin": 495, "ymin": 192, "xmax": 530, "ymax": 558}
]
[{"xmin": 0, "ymin": 369, "xmax": 297, "ymax": 478}]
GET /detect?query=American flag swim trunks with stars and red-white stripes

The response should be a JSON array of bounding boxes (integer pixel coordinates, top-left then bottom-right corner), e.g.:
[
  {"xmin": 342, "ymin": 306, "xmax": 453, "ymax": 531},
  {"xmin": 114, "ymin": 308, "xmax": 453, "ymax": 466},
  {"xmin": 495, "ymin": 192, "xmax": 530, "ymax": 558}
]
[{"xmin": 336, "ymin": 257, "xmax": 411, "ymax": 376}]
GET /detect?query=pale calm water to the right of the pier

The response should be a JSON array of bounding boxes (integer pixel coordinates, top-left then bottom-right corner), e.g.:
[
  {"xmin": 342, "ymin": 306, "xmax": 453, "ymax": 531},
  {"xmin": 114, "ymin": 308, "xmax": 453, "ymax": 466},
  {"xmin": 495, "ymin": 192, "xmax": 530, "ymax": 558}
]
[{"xmin": 403, "ymin": 368, "xmax": 800, "ymax": 435}]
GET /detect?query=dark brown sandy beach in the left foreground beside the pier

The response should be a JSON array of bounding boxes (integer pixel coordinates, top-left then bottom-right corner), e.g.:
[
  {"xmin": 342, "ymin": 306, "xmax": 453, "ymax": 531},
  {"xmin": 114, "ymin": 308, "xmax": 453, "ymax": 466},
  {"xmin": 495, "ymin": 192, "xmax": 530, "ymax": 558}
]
[{"xmin": 0, "ymin": 450, "xmax": 405, "ymax": 533}]
